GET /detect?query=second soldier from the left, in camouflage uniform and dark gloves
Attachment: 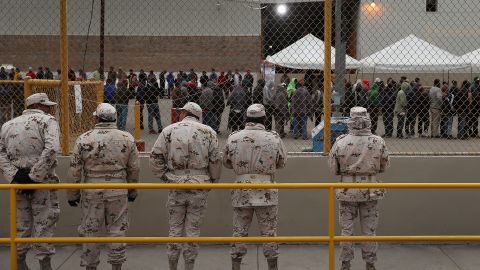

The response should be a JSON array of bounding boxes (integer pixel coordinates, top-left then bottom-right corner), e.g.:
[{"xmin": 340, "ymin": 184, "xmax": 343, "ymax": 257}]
[{"xmin": 68, "ymin": 103, "xmax": 139, "ymax": 270}]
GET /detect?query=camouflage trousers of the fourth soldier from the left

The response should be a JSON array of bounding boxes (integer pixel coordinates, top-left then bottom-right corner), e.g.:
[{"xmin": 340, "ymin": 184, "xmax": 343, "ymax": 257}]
[{"xmin": 230, "ymin": 205, "xmax": 279, "ymax": 260}]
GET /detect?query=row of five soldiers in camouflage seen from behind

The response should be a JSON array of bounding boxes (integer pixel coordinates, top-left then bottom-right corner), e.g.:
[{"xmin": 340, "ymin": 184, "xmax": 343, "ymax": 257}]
[{"xmin": 0, "ymin": 93, "xmax": 389, "ymax": 270}]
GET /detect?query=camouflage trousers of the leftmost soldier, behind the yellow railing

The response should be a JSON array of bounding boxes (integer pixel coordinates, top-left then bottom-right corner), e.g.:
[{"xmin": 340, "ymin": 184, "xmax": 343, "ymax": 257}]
[{"xmin": 17, "ymin": 189, "xmax": 60, "ymax": 260}]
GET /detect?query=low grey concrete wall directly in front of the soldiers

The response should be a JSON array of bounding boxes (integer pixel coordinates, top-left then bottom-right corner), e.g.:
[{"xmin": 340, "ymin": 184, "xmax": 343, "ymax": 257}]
[{"xmin": 0, "ymin": 156, "xmax": 480, "ymax": 237}]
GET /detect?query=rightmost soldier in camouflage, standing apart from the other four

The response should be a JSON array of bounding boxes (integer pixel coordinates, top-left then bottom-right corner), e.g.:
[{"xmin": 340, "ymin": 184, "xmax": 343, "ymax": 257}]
[{"xmin": 329, "ymin": 107, "xmax": 389, "ymax": 270}]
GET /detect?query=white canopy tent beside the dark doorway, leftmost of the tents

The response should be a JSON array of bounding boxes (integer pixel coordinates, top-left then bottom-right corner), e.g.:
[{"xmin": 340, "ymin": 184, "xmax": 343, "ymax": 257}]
[{"xmin": 266, "ymin": 34, "xmax": 360, "ymax": 70}]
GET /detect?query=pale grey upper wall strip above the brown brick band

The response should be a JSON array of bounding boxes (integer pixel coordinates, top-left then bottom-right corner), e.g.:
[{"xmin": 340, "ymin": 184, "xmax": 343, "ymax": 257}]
[{"xmin": 0, "ymin": 0, "xmax": 261, "ymax": 36}]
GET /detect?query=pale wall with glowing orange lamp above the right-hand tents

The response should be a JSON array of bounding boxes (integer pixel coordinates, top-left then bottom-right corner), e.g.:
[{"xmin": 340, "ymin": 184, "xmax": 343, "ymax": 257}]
[{"xmin": 357, "ymin": 0, "xmax": 480, "ymax": 59}]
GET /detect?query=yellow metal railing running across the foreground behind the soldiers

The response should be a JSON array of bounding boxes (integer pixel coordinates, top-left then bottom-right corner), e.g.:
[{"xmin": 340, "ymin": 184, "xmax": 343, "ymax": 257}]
[{"xmin": 0, "ymin": 183, "xmax": 480, "ymax": 270}]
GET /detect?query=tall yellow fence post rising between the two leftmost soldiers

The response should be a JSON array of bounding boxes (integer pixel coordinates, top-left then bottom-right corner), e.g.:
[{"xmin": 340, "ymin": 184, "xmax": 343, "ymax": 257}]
[{"xmin": 60, "ymin": 0, "xmax": 70, "ymax": 155}]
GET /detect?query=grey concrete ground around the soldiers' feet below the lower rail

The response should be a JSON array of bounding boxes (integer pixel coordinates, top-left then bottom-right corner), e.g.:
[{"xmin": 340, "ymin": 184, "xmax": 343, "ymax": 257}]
[{"xmin": 0, "ymin": 244, "xmax": 480, "ymax": 270}]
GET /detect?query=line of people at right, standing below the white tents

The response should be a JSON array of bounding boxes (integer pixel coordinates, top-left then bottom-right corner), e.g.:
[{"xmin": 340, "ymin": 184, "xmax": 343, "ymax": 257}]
[{"xmin": 343, "ymin": 77, "xmax": 480, "ymax": 139}]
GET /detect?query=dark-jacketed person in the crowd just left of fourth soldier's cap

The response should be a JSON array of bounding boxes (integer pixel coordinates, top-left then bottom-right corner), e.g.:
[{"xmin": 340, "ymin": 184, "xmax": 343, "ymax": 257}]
[{"xmin": 227, "ymin": 82, "xmax": 250, "ymax": 132}]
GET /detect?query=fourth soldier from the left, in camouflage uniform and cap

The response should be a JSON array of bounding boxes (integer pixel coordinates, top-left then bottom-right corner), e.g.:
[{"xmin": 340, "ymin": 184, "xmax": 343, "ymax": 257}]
[{"xmin": 223, "ymin": 104, "xmax": 287, "ymax": 270}]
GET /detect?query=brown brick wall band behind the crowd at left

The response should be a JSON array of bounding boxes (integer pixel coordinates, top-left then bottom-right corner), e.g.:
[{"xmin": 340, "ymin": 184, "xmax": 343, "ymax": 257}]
[{"xmin": 0, "ymin": 36, "xmax": 261, "ymax": 71}]
